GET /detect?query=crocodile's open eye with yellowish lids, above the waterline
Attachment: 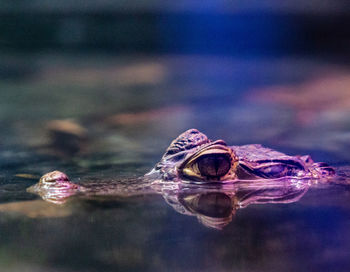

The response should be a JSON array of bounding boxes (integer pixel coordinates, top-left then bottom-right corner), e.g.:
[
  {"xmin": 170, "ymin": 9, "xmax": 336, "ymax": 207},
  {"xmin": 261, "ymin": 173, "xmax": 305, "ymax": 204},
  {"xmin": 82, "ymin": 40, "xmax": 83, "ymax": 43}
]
[{"xmin": 180, "ymin": 147, "xmax": 237, "ymax": 180}]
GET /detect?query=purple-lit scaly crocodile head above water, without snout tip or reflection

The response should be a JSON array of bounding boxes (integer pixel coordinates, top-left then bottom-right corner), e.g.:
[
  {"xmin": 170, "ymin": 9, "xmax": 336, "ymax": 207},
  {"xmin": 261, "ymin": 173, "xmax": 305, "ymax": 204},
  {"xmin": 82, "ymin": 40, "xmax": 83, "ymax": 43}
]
[{"xmin": 150, "ymin": 129, "xmax": 335, "ymax": 182}]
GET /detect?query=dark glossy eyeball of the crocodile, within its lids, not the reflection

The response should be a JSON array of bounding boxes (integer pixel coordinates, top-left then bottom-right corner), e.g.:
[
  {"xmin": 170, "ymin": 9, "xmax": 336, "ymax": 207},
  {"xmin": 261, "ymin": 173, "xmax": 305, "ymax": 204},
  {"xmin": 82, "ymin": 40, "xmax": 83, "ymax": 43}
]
[{"xmin": 197, "ymin": 154, "xmax": 231, "ymax": 177}]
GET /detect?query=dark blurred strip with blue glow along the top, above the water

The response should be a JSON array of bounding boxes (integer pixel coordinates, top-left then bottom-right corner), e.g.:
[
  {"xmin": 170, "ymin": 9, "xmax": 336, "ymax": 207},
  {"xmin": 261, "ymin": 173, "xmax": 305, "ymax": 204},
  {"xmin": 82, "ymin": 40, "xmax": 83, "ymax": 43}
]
[{"xmin": 0, "ymin": 0, "xmax": 349, "ymax": 55}]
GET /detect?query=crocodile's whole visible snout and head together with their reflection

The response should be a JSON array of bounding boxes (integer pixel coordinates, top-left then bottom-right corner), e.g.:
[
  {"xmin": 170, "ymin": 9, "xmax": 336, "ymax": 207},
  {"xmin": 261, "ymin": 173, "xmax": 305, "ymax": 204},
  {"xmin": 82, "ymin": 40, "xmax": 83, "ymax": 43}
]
[{"xmin": 28, "ymin": 129, "xmax": 335, "ymax": 229}]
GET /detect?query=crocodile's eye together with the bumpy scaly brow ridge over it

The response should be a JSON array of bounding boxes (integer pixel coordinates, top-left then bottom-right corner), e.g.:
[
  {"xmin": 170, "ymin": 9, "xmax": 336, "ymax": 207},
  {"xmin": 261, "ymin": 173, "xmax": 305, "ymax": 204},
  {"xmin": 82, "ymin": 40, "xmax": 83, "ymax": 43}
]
[{"xmin": 155, "ymin": 129, "xmax": 238, "ymax": 182}]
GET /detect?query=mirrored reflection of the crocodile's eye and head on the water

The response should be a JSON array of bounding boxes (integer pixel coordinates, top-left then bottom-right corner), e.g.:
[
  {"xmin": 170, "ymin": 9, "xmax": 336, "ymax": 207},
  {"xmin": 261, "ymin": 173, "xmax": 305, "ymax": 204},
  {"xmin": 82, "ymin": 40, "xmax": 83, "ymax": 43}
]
[{"xmin": 163, "ymin": 179, "xmax": 310, "ymax": 230}]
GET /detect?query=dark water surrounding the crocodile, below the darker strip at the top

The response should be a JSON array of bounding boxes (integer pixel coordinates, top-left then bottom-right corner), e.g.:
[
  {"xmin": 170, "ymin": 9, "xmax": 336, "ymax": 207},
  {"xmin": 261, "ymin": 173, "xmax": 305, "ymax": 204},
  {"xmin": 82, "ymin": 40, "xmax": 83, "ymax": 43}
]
[{"xmin": 0, "ymin": 55, "xmax": 350, "ymax": 271}]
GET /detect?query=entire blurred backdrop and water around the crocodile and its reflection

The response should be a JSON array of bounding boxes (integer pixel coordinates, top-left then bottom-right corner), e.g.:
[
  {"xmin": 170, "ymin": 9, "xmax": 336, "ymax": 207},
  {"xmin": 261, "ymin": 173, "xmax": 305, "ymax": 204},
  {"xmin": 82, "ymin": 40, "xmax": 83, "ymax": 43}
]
[{"xmin": 0, "ymin": 0, "xmax": 350, "ymax": 272}]
